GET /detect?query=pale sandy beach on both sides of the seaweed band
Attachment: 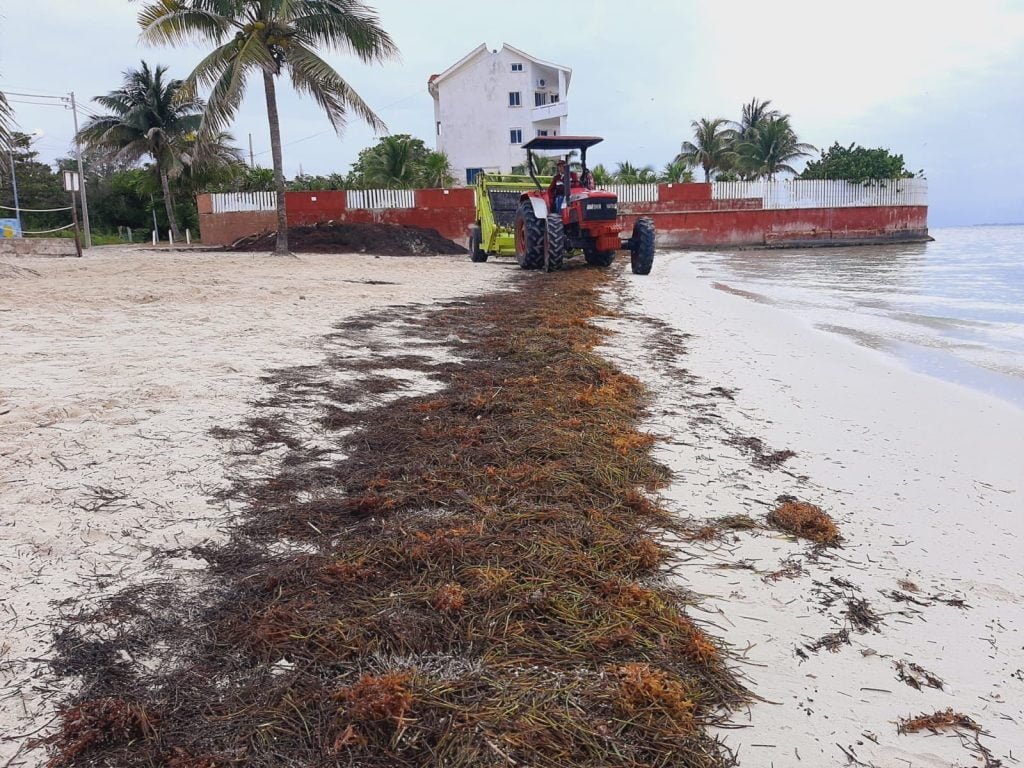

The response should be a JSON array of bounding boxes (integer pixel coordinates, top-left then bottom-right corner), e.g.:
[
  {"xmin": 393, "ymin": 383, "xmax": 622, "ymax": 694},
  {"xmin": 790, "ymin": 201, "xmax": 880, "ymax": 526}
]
[{"xmin": 0, "ymin": 249, "xmax": 1024, "ymax": 768}]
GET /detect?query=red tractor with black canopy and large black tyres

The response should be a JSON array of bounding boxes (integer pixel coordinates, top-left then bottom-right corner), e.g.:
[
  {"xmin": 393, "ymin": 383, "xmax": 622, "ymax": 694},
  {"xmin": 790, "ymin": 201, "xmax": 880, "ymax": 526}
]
[{"xmin": 515, "ymin": 136, "xmax": 654, "ymax": 274}]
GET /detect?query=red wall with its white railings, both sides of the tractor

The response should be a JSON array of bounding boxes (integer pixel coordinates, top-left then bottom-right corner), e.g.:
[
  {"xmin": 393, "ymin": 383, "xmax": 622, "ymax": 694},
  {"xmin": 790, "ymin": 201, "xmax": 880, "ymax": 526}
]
[{"xmin": 198, "ymin": 179, "xmax": 928, "ymax": 248}]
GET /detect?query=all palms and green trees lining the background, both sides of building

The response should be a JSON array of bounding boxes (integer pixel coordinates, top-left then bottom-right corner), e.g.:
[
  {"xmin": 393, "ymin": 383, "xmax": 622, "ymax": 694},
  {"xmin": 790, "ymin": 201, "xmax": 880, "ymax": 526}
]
[{"xmin": 0, "ymin": 0, "xmax": 911, "ymax": 253}]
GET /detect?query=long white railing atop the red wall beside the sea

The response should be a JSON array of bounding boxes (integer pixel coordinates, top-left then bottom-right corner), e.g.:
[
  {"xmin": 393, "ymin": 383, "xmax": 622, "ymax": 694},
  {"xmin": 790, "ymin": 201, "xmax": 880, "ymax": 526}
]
[{"xmin": 711, "ymin": 178, "xmax": 928, "ymax": 209}]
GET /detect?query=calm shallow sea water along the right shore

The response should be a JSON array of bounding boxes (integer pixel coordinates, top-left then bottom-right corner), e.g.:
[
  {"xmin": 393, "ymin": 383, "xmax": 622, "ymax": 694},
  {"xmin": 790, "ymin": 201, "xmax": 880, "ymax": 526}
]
[{"xmin": 690, "ymin": 225, "xmax": 1024, "ymax": 408}]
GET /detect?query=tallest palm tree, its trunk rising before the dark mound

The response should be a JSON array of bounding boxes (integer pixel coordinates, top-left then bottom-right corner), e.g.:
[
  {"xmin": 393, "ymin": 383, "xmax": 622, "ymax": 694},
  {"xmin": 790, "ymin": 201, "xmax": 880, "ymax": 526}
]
[{"xmin": 138, "ymin": 0, "xmax": 398, "ymax": 259}]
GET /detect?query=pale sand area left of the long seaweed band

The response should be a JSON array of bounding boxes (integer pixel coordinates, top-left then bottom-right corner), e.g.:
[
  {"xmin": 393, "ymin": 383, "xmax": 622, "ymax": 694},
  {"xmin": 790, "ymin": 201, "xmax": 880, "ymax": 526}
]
[{"xmin": 0, "ymin": 249, "xmax": 509, "ymax": 766}]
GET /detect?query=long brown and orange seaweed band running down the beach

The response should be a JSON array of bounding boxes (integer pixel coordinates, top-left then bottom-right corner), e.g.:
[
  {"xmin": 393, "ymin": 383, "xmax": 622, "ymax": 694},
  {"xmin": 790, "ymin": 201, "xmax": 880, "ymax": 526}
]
[{"xmin": 48, "ymin": 267, "xmax": 744, "ymax": 768}]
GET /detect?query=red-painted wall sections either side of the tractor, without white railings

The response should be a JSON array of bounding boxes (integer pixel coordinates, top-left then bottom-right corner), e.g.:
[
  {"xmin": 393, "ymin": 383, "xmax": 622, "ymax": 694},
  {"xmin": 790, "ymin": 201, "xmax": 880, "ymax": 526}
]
[{"xmin": 197, "ymin": 183, "xmax": 928, "ymax": 247}]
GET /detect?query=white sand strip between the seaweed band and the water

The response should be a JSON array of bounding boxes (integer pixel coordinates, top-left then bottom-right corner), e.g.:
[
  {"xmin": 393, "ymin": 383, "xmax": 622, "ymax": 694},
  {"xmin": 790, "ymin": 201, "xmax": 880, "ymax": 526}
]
[{"xmin": 612, "ymin": 254, "xmax": 1024, "ymax": 768}]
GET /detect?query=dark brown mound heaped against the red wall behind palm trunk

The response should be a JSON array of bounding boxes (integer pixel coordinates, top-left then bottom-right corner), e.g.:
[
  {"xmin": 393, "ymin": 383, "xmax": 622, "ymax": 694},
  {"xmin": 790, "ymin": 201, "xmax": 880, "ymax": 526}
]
[{"xmin": 227, "ymin": 222, "xmax": 466, "ymax": 256}]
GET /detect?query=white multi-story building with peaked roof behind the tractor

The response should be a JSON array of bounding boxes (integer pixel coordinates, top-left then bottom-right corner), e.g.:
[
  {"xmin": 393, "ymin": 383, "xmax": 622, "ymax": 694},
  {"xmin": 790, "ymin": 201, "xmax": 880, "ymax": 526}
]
[{"xmin": 427, "ymin": 43, "xmax": 572, "ymax": 184}]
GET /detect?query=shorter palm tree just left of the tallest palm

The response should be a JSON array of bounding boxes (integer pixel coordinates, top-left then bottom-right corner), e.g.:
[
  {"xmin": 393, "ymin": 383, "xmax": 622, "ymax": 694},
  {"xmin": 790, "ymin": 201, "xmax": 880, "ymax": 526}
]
[{"xmin": 78, "ymin": 61, "xmax": 203, "ymax": 239}]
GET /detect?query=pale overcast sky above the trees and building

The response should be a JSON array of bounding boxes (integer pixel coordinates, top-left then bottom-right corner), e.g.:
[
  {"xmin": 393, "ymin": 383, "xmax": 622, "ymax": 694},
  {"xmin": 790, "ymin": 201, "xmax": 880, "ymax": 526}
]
[{"xmin": 0, "ymin": 0, "xmax": 1024, "ymax": 226}]
